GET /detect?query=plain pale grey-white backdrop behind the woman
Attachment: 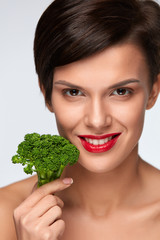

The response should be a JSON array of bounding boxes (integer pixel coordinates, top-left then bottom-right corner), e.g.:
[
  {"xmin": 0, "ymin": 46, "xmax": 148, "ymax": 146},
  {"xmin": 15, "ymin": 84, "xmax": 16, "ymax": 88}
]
[{"xmin": 0, "ymin": 0, "xmax": 160, "ymax": 187}]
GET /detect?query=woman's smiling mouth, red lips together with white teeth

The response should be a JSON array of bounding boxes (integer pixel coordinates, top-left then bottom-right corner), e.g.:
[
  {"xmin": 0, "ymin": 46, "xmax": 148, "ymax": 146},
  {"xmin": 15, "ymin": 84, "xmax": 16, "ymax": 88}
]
[{"xmin": 79, "ymin": 133, "xmax": 121, "ymax": 153}]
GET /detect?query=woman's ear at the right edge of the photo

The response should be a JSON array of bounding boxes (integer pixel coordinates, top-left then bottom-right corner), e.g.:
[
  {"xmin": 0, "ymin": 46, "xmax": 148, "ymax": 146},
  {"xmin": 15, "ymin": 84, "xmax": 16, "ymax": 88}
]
[{"xmin": 146, "ymin": 74, "xmax": 160, "ymax": 110}]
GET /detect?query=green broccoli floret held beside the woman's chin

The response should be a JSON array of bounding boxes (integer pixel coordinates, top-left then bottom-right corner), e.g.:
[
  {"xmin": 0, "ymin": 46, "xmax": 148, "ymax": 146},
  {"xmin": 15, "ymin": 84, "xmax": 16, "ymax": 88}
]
[{"xmin": 12, "ymin": 133, "xmax": 79, "ymax": 187}]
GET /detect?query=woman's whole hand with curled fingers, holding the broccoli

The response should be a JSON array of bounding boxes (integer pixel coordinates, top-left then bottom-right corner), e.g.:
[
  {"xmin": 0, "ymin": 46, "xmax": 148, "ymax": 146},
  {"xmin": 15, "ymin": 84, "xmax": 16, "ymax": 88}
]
[{"xmin": 14, "ymin": 178, "xmax": 72, "ymax": 240}]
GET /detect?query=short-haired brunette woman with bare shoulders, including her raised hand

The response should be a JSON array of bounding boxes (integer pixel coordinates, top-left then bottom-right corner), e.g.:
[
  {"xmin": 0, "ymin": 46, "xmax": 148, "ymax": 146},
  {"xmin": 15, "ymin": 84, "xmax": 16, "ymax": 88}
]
[{"xmin": 0, "ymin": 0, "xmax": 160, "ymax": 240}]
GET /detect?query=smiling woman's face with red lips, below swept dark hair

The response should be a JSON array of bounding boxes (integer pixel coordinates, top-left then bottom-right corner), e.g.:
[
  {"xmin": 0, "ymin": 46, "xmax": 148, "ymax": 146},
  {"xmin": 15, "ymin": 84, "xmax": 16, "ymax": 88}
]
[{"xmin": 50, "ymin": 44, "xmax": 156, "ymax": 173}]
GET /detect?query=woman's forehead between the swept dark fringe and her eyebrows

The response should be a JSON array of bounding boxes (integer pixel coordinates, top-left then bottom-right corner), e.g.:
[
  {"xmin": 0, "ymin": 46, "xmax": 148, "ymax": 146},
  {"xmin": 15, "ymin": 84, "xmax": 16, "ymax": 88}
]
[{"xmin": 54, "ymin": 44, "xmax": 149, "ymax": 86}]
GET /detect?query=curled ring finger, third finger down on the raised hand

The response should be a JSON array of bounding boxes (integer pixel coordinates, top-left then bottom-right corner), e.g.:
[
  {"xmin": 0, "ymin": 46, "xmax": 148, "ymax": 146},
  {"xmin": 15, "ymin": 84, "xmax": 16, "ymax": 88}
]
[{"xmin": 40, "ymin": 206, "xmax": 62, "ymax": 226}]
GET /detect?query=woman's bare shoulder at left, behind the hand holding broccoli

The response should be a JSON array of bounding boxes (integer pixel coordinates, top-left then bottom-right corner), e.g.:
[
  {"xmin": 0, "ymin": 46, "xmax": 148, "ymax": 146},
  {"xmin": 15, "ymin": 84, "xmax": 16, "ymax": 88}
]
[{"xmin": 0, "ymin": 177, "xmax": 36, "ymax": 240}]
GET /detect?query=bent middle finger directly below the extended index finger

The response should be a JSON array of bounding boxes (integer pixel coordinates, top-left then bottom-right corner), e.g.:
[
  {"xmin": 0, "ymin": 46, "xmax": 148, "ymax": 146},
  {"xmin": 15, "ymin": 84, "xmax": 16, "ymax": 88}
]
[{"xmin": 30, "ymin": 194, "xmax": 64, "ymax": 218}]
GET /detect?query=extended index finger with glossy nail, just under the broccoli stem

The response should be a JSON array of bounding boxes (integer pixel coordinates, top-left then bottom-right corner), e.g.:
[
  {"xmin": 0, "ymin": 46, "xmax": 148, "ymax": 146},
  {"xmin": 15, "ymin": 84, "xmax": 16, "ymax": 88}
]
[{"xmin": 21, "ymin": 178, "xmax": 73, "ymax": 208}]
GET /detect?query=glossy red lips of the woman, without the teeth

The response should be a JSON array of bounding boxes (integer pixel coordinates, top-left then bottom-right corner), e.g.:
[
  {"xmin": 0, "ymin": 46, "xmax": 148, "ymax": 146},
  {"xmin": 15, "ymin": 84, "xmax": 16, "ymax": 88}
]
[{"xmin": 79, "ymin": 133, "xmax": 121, "ymax": 153}]
